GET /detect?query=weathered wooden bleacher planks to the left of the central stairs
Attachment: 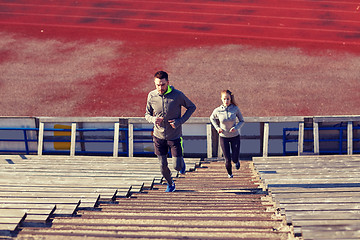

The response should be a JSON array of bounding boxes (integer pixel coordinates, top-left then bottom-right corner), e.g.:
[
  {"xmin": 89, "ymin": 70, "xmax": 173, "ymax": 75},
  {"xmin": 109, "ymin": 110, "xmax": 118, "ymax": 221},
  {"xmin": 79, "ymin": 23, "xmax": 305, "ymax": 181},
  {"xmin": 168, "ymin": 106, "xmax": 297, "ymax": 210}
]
[{"xmin": 0, "ymin": 155, "xmax": 200, "ymax": 235}]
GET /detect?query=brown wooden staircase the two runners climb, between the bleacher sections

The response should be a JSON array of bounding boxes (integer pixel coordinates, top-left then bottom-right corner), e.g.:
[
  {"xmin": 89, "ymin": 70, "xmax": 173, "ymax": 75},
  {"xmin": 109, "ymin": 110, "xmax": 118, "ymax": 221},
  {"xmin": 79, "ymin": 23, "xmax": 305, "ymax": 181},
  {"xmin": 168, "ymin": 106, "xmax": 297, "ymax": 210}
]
[{"xmin": 14, "ymin": 161, "xmax": 294, "ymax": 240}]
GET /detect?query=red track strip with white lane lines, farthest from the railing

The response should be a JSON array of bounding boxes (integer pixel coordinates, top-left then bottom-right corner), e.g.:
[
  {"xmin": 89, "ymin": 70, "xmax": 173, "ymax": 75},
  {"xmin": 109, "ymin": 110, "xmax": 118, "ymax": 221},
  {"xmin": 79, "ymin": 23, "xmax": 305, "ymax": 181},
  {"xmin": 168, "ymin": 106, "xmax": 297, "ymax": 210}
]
[{"xmin": 0, "ymin": 0, "xmax": 360, "ymax": 45}]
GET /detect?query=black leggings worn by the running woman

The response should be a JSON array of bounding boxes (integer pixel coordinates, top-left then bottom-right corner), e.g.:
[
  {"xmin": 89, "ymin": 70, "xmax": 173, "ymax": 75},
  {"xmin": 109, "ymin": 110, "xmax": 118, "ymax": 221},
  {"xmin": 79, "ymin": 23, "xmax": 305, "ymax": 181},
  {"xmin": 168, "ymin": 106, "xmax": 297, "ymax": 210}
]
[{"xmin": 220, "ymin": 135, "xmax": 240, "ymax": 175}]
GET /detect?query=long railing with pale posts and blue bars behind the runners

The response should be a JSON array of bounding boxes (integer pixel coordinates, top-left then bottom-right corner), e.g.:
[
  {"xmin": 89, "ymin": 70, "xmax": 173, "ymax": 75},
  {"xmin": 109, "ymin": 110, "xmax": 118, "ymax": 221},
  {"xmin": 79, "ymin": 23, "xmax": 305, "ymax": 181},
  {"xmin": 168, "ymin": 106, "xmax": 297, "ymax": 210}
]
[{"xmin": 0, "ymin": 116, "xmax": 360, "ymax": 158}]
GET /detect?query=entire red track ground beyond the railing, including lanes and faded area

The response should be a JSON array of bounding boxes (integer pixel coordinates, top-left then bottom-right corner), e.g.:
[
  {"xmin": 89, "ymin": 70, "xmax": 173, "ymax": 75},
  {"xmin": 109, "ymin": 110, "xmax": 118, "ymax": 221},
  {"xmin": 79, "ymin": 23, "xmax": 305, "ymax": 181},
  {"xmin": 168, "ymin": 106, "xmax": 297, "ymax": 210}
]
[{"xmin": 0, "ymin": 0, "xmax": 360, "ymax": 116}]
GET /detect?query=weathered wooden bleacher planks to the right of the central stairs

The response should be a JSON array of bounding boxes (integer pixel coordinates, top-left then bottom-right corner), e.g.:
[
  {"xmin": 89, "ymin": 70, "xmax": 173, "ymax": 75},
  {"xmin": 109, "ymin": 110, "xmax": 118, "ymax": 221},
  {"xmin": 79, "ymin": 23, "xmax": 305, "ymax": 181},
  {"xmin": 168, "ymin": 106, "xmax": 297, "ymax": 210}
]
[{"xmin": 253, "ymin": 155, "xmax": 360, "ymax": 239}]
